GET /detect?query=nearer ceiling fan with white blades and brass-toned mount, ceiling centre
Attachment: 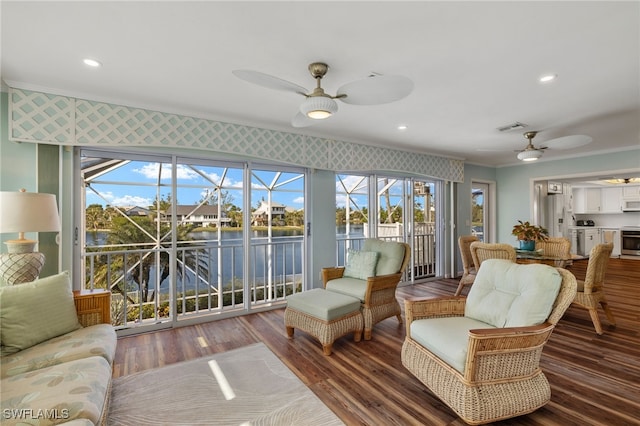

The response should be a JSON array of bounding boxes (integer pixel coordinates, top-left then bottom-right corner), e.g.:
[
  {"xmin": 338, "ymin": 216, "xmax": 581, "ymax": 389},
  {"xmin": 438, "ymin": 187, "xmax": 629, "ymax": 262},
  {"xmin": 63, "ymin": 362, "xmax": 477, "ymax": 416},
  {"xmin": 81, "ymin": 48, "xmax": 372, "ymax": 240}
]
[{"xmin": 232, "ymin": 62, "xmax": 413, "ymax": 127}]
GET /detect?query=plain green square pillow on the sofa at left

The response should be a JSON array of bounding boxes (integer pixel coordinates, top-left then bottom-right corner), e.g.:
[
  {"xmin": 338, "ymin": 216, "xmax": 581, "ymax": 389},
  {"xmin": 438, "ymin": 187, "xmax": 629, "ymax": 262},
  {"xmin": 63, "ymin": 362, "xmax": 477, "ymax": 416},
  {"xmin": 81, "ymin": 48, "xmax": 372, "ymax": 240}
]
[{"xmin": 0, "ymin": 271, "xmax": 82, "ymax": 352}]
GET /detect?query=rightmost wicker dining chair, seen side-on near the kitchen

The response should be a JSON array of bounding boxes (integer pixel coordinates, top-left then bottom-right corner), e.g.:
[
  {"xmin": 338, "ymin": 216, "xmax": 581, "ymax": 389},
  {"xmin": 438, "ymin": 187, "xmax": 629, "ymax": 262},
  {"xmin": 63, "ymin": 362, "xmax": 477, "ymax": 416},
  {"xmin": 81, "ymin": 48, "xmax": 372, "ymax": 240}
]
[{"xmin": 573, "ymin": 243, "xmax": 616, "ymax": 334}]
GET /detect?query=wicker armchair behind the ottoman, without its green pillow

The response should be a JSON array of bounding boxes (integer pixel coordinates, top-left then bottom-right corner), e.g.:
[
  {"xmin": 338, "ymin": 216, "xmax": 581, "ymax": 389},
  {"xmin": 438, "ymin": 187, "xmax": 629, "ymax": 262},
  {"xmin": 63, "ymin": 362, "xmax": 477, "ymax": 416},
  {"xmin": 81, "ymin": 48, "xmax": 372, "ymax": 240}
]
[{"xmin": 322, "ymin": 239, "xmax": 411, "ymax": 340}]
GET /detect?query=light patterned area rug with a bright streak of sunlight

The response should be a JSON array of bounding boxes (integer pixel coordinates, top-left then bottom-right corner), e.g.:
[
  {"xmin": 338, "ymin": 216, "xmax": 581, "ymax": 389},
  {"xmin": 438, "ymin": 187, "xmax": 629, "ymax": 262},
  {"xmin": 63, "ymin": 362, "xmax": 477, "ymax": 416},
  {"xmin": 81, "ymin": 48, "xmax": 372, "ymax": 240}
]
[{"xmin": 107, "ymin": 343, "xmax": 344, "ymax": 426}]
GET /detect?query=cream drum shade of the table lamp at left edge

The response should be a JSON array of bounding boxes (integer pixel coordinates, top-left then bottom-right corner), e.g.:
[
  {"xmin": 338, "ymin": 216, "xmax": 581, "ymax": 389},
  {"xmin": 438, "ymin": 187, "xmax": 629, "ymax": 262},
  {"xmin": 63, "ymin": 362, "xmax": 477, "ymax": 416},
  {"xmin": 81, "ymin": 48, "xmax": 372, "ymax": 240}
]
[{"xmin": 0, "ymin": 190, "xmax": 60, "ymax": 233}]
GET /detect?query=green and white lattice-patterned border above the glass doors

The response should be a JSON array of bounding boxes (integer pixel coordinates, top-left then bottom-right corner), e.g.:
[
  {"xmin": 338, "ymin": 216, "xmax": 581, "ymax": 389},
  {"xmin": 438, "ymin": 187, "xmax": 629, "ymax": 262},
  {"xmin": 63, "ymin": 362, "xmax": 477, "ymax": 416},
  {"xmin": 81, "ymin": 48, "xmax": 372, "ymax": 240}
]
[{"xmin": 9, "ymin": 88, "xmax": 464, "ymax": 182}]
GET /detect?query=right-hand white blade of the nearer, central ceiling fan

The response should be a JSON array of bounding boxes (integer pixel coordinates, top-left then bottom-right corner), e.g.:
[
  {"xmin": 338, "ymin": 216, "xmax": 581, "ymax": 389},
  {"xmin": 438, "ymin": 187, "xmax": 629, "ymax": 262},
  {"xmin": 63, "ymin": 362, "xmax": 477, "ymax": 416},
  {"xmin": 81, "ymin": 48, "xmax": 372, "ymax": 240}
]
[{"xmin": 337, "ymin": 74, "xmax": 413, "ymax": 105}]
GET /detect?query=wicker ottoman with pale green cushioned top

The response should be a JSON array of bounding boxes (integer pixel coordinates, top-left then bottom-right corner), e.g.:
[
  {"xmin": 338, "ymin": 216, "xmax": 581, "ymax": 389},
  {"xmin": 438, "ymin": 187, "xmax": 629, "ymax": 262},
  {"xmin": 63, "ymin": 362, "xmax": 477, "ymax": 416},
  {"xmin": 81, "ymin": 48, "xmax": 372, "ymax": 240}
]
[{"xmin": 284, "ymin": 288, "xmax": 364, "ymax": 355}]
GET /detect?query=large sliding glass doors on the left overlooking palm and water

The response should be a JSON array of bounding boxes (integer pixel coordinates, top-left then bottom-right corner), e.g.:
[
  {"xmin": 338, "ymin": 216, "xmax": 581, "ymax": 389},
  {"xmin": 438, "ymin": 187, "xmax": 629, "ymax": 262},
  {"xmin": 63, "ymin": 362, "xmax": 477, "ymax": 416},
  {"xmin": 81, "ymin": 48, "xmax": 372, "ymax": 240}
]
[{"xmin": 77, "ymin": 150, "xmax": 305, "ymax": 329}]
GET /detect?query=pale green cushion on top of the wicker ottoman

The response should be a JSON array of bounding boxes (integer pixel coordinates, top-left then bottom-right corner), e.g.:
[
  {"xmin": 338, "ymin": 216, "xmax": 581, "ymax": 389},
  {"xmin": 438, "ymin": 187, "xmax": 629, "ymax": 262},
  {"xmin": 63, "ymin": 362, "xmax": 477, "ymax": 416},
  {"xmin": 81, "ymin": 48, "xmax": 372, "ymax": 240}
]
[{"xmin": 287, "ymin": 288, "xmax": 360, "ymax": 321}]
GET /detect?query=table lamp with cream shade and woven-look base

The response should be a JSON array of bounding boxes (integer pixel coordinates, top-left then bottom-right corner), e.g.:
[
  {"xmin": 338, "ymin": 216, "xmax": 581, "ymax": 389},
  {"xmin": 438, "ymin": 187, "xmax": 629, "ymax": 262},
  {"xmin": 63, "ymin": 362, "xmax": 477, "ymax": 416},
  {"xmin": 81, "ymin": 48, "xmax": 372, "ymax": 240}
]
[{"xmin": 0, "ymin": 189, "xmax": 60, "ymax": 285}]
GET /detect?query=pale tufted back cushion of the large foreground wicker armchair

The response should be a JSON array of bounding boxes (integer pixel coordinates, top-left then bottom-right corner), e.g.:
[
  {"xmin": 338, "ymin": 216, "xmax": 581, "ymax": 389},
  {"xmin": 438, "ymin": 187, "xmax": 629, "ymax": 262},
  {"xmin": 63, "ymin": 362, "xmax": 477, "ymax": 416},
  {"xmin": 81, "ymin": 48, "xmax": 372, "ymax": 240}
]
[{"xmin": 464, "ymin": 259, "xmax": 562, "ymax": 327}]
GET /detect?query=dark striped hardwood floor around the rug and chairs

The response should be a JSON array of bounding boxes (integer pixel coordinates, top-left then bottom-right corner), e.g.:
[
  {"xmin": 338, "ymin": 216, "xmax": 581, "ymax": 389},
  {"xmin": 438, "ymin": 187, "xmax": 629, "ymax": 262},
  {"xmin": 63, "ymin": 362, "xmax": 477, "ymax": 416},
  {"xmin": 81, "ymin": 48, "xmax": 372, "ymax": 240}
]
[{"xmin": 114, "ymin": 259, "xmax": 640, "ymax": 426}]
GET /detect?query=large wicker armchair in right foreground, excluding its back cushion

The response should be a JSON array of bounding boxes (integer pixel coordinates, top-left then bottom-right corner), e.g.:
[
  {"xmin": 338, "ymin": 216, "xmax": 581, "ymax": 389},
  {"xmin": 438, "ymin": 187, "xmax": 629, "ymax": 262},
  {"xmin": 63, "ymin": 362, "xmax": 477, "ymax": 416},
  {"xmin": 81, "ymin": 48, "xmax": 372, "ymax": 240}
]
[{"xmin": 401, "ymin": 261, "xmax": 577, "ymax": 424}]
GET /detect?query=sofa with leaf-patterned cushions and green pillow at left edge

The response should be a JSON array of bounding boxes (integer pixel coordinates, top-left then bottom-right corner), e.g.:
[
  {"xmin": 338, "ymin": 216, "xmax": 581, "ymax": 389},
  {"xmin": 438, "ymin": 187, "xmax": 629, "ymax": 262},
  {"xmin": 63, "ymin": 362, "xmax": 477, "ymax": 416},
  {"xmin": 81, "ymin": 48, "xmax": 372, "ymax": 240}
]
[{"xmin": 0, "ymin": 272, "xmax": 116, "ymax": 426}]
